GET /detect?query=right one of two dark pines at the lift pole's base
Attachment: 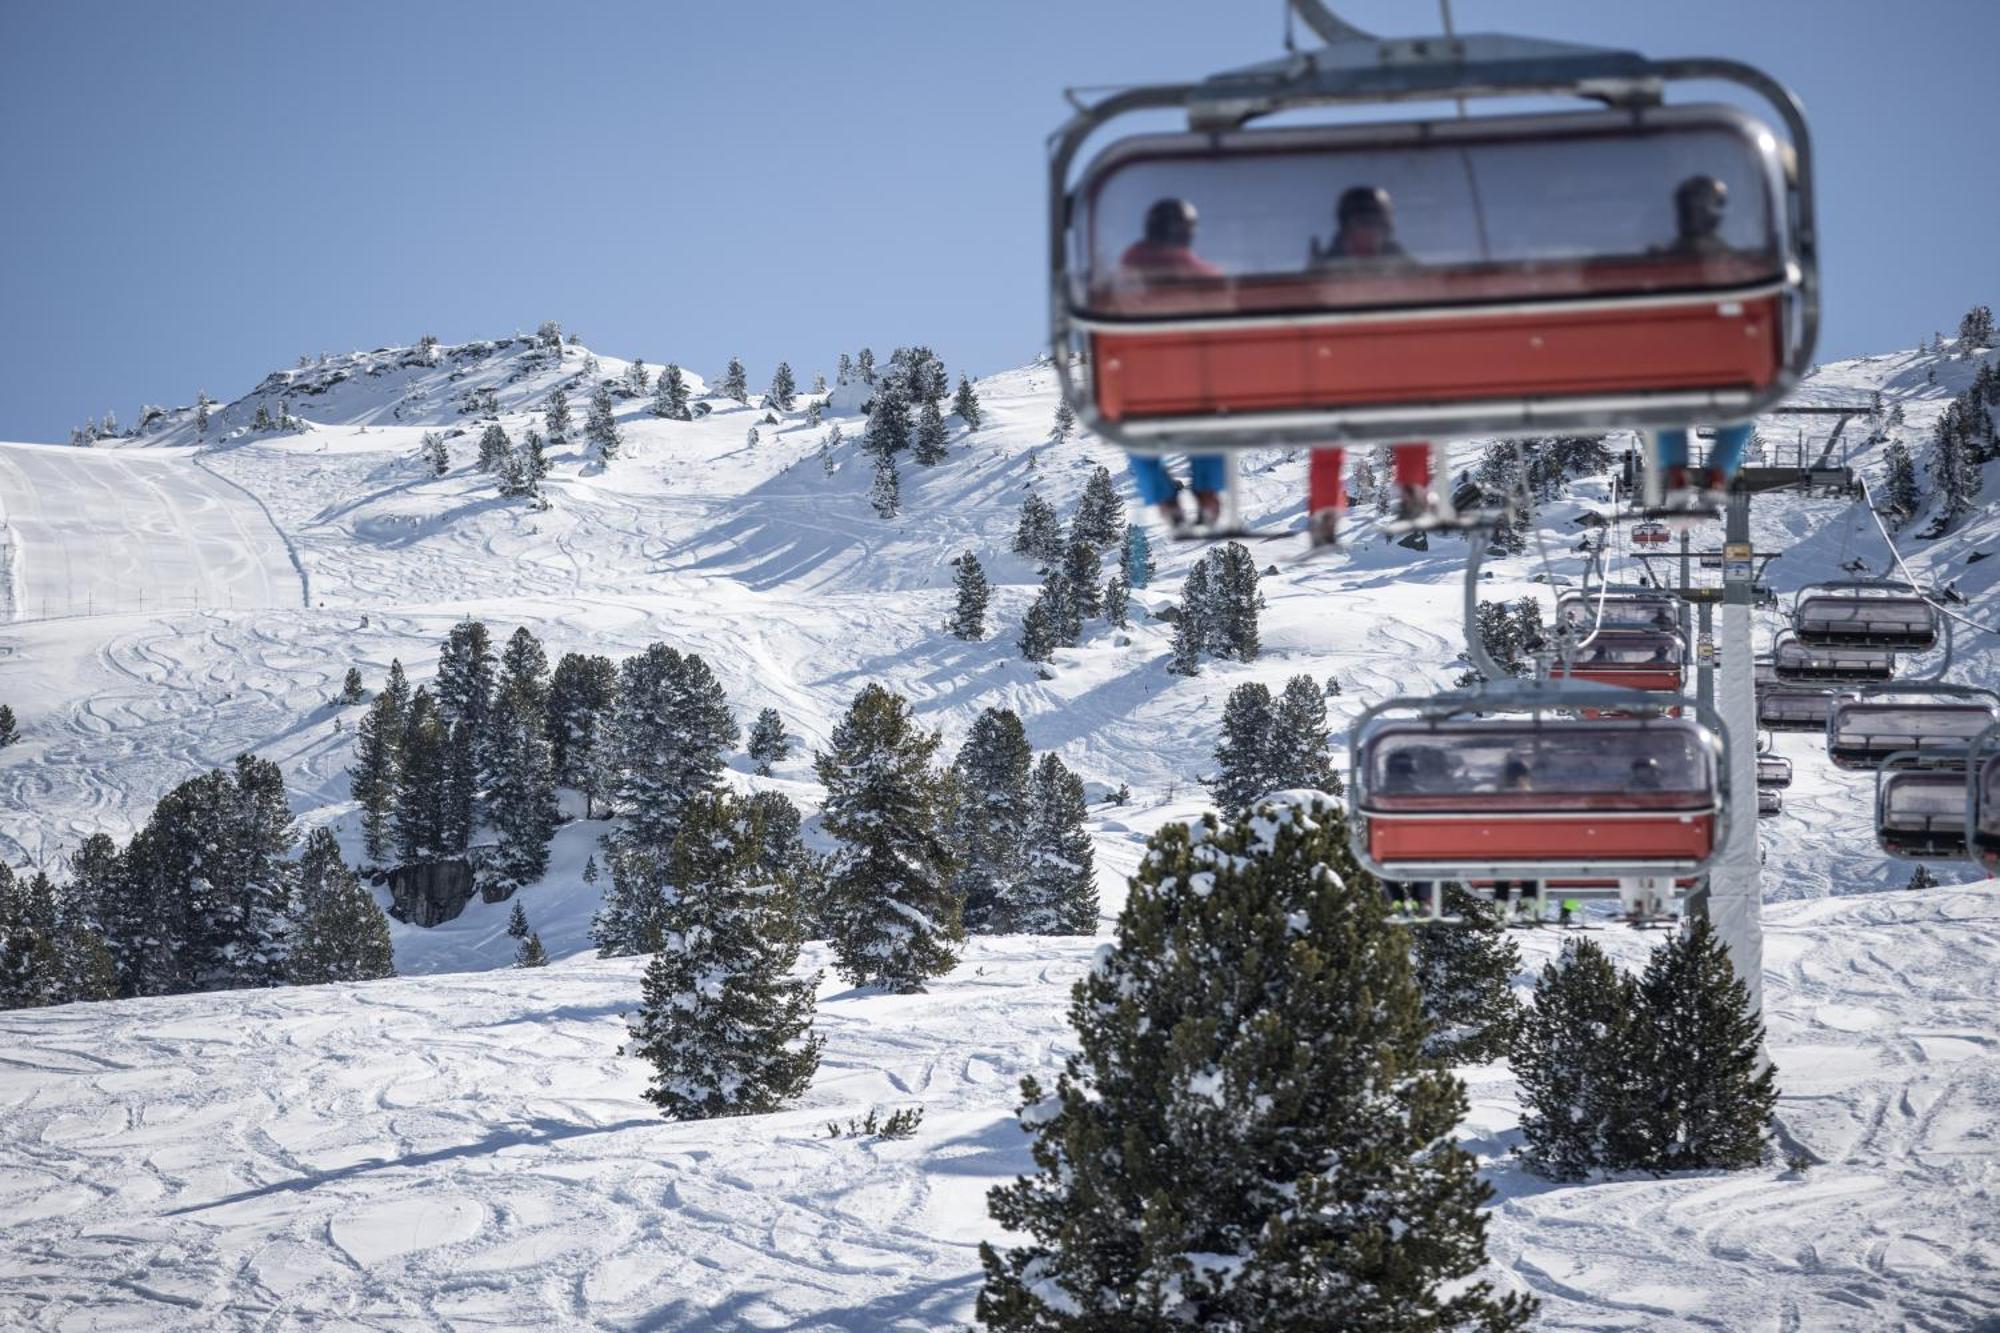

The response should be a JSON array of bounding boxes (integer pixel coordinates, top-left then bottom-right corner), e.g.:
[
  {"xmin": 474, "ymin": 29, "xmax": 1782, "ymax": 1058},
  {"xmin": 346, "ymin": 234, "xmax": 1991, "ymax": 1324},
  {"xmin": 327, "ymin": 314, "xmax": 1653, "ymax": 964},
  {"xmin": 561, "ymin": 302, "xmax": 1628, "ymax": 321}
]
[{"xmin": 1610, "ymin": 917, "xmax": 1778, "ymax": 1173}]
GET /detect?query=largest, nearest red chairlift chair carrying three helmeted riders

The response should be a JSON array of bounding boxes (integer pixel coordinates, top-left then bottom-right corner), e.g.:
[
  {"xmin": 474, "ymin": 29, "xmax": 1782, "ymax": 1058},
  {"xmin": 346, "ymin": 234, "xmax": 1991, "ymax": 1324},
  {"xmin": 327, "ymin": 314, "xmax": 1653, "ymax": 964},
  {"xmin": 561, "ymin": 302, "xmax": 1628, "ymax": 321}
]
[{"xmin": 1048, "ymin": 19, "xmax": 1818, "ymax": 454}]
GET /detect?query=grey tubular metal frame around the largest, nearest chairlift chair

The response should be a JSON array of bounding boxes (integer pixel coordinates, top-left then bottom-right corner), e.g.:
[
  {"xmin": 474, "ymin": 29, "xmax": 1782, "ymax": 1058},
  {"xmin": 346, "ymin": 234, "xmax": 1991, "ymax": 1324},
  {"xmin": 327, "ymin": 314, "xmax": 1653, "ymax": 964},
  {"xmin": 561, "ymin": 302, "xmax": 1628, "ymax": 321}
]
[{"xmin": 1048, "ymin": 0, "xmax": 1820, "ymax": 454}]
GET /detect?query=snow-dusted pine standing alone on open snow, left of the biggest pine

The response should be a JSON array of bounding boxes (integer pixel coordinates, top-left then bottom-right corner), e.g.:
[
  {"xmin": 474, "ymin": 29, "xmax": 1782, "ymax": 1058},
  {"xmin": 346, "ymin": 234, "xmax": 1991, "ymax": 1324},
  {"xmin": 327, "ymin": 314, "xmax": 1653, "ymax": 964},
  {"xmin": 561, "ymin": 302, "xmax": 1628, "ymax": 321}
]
[{"xmin": 624, "ymin": 793, "xmax": 822, "ymax": 1121}]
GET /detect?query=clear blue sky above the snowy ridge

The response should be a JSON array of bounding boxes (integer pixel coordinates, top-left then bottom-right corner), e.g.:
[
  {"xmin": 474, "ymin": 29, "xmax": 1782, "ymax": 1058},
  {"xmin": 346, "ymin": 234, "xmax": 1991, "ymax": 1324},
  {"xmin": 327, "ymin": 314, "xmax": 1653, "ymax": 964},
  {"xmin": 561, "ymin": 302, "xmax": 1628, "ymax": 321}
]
[{"xmin": 0, "ymin": 0, "xmax": 2000, "ymax": 438}]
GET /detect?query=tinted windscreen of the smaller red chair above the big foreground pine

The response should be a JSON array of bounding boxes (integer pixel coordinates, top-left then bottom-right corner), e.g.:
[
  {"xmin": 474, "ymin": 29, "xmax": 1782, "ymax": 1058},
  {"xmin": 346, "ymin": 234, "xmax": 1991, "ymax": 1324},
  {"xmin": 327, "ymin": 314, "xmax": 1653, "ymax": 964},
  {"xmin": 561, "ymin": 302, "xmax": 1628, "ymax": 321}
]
[{"xmin": 1364, "ymin": 721, "xmax": 1714, "ymax": 809}]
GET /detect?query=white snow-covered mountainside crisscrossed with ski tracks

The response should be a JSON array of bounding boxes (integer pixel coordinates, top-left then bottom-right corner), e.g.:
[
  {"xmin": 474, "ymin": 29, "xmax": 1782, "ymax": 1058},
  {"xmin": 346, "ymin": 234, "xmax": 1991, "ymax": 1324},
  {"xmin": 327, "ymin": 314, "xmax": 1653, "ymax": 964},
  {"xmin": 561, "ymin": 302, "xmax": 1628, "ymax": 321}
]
[{"xmin": 0, "ymin": 348, "xmax": 2000, "ymax": 1329}]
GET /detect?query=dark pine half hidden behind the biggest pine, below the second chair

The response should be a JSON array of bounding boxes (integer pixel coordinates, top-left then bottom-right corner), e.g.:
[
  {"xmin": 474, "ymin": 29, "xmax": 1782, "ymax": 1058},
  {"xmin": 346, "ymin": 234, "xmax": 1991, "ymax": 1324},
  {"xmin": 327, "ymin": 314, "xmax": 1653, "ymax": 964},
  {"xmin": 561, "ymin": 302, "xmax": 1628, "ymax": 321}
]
[{"xmin": 1410, "ymin": 885, "xmax": 1520, "ymax": 1065}]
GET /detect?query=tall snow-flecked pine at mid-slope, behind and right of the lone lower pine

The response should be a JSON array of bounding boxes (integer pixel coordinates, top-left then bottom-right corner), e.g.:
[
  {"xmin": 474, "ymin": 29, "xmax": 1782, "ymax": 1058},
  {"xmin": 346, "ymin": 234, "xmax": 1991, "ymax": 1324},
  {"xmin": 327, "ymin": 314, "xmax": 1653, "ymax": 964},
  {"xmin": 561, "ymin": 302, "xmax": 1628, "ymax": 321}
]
[{"xmin": 814, "ymin": 685, "xmax": 964, "ymax": 995}]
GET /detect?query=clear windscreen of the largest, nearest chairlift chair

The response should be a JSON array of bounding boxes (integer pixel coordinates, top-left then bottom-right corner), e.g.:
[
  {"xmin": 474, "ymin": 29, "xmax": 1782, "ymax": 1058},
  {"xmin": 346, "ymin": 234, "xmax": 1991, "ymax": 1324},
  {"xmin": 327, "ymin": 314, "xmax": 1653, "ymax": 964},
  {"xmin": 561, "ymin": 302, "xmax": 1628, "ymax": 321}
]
[{"xmin": 1070, "ymin": 108, "xmax": 1784, "ymax": 318}]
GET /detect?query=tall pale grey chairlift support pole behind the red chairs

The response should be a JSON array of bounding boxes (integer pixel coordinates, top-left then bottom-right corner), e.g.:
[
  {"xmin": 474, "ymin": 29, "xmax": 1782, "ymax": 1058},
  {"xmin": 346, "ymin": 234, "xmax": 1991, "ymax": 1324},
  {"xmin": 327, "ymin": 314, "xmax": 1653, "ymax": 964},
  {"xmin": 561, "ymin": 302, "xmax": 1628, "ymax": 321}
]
[{"xmin": 1700, "ymin": 482, "xmax": 1764, "ymax": 1017}]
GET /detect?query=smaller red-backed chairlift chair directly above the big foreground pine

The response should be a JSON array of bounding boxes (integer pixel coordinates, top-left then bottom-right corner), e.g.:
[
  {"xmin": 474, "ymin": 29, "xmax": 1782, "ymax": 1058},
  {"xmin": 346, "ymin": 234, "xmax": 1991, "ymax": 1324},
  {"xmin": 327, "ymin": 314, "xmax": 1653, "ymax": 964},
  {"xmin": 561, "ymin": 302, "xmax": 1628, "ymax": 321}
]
[{"xmin": 1350, "ymin": 681, "xmax": 1728, "ymax": 881}]
